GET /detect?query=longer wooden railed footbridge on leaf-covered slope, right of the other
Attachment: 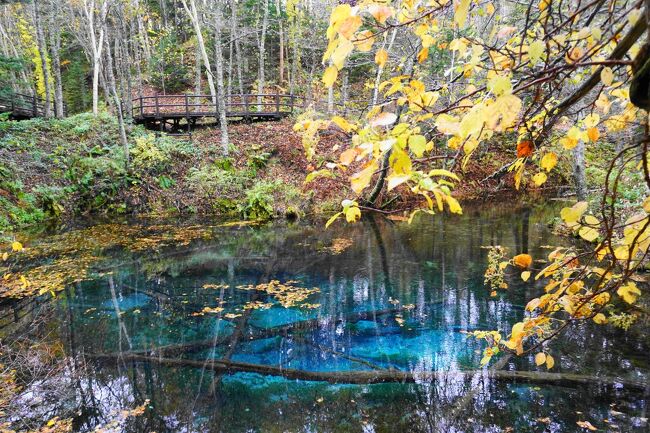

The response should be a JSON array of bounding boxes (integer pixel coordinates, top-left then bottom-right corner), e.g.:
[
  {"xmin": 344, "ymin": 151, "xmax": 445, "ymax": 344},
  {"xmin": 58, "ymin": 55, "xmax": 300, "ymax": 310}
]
[{"xmin": 132, "ymin": 93, "xmax": 338, "ymax": 132}]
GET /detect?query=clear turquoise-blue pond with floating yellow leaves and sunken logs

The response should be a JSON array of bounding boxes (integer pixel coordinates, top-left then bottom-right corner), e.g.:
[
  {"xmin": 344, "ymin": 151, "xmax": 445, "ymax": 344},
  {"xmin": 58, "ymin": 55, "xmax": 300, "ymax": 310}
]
[{"xmin": 1, "ymin": 204, "xmax": 650, "ymax": 433}]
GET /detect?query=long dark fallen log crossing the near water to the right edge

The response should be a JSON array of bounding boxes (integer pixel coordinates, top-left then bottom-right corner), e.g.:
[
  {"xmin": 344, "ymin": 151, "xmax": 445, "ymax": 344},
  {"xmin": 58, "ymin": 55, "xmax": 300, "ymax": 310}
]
[{"xmin": 88, "ymin": 354, "xmax": 649, "ymax": 391}]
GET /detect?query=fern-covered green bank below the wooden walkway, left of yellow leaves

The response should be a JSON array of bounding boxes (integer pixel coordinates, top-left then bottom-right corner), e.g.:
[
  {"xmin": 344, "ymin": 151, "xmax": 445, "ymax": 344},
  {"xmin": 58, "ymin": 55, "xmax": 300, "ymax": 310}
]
[{"xmin": 0, "ymin": 113, "xmax": 334, "ymax": 232}]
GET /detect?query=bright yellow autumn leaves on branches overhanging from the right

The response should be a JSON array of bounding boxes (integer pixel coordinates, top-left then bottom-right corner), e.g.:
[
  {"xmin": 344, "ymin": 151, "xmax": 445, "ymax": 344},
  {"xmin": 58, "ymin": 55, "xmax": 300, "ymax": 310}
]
[{"xmin": 296, "ymin": 0, "xmax": 650, "ymax": 368}]
